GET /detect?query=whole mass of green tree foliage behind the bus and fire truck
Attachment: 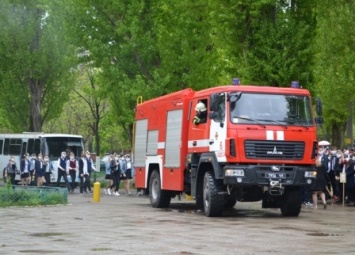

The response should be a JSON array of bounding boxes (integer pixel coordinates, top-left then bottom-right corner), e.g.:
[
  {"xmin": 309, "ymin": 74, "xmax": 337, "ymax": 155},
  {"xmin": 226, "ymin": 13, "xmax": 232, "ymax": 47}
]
[{"xmin": 0, "ymin": 0, "xmax": 355, "ymax": 149}]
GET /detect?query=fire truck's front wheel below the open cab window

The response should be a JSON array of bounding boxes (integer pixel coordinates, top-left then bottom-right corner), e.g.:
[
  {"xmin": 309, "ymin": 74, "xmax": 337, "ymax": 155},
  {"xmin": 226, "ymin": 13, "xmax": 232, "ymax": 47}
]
[{"xmin": 203, "ymin": 172, "xmax": 224, "ymax": 217}]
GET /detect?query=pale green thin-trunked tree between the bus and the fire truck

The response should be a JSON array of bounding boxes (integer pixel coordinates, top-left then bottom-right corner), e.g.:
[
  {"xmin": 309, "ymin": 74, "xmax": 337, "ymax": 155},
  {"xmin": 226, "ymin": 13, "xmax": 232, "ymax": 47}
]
[{"xmin": 44, "ymin": 63, "xmax": 109, "ymax": 154}]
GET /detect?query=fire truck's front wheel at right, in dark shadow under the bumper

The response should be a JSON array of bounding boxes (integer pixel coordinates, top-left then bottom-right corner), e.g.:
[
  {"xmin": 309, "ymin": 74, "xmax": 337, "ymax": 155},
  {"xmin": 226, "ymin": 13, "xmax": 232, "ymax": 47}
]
[{"xmin": 280, "ymin": 189, "xmax": 301, "ymax": 217}]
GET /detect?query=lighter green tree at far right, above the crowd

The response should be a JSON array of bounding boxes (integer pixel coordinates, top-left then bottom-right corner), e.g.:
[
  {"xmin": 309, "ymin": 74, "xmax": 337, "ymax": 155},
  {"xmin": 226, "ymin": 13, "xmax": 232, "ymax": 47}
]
[{"xmin": 314, "ymin": 0, "xmax": 355, "ymax": 147}]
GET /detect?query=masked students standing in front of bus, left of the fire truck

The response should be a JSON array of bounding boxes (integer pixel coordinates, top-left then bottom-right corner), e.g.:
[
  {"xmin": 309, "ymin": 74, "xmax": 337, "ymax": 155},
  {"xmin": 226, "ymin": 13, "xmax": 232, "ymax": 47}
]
[{"xmin": 4, "ymin": 151, "xmax": 133, "ymax": 196}]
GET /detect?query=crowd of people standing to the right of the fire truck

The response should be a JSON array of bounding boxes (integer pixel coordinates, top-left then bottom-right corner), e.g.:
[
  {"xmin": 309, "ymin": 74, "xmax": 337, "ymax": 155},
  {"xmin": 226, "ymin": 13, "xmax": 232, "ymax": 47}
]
[{"xmin": 303, "ymin": 147, "xmax": 355, "ymax": 209}]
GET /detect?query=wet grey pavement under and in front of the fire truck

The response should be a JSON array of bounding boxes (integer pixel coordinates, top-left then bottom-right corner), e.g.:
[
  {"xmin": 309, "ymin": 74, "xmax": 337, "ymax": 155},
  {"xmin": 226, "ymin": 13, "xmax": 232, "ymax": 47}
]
[{"xmin": 0, "ymin": 187, "xmax": 355, "ymax": 255}]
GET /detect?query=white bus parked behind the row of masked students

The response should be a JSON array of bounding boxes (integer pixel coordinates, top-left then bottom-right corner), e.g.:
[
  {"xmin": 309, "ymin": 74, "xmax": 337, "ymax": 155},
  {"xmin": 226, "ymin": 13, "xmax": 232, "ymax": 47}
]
[{"xmin": 0, "ymin": 132, "xmax": 84, "ymax": 183}]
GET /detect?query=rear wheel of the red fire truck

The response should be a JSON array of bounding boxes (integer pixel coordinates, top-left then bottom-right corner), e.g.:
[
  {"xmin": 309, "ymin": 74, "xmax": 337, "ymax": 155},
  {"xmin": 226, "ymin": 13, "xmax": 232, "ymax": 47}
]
[{"xmin": 149, "ymin": 170, "xmax": 171, "ymax": 208}]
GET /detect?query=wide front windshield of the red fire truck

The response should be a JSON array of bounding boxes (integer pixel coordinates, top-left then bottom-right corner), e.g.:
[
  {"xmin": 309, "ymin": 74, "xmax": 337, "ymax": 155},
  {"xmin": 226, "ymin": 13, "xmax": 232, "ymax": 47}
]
[{"xmin": 230, "ymin": 92, "xmax": 313, "ymax": 126}]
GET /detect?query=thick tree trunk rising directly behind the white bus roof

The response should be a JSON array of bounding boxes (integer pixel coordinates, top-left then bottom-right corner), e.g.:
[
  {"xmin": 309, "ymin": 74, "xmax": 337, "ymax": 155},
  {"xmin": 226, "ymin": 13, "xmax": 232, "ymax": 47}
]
[{"xmin": 28, "ymin": 79, "xmax": 43, "ymax": 132}]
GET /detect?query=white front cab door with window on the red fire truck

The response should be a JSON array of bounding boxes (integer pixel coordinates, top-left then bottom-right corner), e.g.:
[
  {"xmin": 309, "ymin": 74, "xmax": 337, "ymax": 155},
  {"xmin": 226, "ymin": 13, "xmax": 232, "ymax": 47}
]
[{"xmin": 209, "ymin": 93, "xmax": 227, "ymax": 162}]
